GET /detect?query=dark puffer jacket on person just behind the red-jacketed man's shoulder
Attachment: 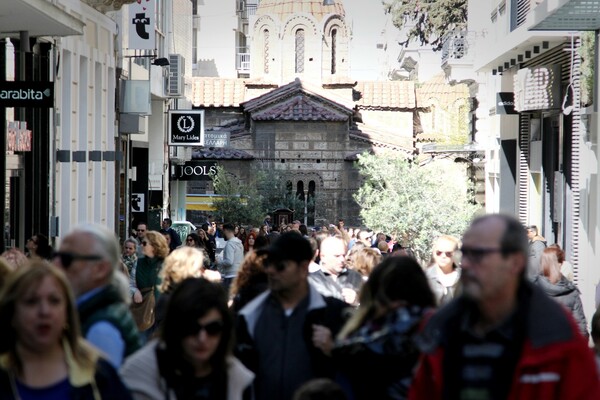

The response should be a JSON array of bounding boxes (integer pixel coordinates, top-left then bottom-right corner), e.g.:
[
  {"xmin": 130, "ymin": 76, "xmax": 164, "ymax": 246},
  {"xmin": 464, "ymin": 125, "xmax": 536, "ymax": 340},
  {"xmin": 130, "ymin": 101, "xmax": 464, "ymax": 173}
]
[{"xmin": 534, "ymin": 275, "xmax": 589, "ymax": 337}]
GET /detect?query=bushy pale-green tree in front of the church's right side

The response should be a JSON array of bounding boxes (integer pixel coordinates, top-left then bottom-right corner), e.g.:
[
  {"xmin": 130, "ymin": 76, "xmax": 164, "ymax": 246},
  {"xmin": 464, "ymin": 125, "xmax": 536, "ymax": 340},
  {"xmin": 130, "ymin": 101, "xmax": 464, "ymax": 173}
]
[{"xmin": 355, "ymin": 153, "xmax": 479, "ymax": 261}]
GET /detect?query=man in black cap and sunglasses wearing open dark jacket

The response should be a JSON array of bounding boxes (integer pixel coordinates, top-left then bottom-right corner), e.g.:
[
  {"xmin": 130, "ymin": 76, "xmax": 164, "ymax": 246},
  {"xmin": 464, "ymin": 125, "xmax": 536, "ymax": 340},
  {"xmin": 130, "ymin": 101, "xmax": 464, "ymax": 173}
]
[{"xmin": 235, "ymin": 231, "xmax": 346, "ymax": 400}]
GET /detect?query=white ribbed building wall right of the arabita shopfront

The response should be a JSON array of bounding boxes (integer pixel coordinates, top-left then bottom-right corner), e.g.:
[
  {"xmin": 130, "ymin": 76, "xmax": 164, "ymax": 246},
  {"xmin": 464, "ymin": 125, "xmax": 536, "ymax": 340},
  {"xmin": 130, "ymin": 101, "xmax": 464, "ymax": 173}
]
[{"xmin": 51, "ymin": 0, "xmax": 117, "ymax": 236}]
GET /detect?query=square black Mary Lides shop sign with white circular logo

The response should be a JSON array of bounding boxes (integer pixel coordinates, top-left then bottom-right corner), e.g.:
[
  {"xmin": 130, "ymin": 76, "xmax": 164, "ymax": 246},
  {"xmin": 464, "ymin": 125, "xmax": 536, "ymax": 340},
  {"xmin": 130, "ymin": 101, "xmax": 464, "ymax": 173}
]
[{"xmin": 169, "ymin": 110, "xmax": 204, "ymax": 146}]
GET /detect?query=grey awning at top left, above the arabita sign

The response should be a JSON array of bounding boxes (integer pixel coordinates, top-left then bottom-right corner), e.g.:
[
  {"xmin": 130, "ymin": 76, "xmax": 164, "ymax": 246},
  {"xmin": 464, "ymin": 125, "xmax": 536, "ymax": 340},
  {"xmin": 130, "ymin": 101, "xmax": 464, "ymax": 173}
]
[{"xmin": 0, "ymin": 0, "xmax": 85, "ymax": 37}]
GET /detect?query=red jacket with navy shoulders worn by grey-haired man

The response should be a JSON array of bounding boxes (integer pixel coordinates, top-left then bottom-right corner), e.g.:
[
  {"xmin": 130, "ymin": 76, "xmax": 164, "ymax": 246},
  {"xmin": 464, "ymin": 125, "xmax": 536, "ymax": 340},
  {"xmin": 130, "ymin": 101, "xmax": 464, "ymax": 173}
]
[{"xmin": 409, "ymin": 284, "xmax": 600, "ymax": 400}]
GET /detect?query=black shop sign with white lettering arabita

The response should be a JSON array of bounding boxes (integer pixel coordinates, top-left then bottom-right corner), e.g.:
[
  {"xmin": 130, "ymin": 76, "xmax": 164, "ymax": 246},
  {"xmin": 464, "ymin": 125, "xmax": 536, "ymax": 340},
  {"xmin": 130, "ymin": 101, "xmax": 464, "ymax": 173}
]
[{"xmin": 0, "ymin": 81, "xmax": 54, "ymax": 108}]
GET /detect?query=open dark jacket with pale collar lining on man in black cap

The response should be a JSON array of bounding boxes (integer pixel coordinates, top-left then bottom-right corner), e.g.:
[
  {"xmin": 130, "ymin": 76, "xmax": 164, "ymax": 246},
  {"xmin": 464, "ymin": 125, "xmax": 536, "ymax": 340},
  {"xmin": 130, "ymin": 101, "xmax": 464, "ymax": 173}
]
[{"xmin": 234, "ymin": 285, "xmax": 348, "ymax": 377}]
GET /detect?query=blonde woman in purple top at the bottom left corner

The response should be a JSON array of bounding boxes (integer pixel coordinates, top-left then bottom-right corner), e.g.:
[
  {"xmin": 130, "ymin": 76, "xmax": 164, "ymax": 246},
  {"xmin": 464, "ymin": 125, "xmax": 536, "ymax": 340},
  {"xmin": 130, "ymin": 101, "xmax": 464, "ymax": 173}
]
[{"xmin": 0, "ymin": 260, "xmax": 131, "ymax": 400}]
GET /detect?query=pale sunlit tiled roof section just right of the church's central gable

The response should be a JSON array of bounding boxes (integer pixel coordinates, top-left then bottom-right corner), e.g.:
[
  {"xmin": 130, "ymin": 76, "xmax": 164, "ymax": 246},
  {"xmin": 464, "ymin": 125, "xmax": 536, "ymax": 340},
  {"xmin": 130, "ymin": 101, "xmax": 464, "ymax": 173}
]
[{"xmin": 354, "ymin": 81, "xmax": 416, "ymax": 110}]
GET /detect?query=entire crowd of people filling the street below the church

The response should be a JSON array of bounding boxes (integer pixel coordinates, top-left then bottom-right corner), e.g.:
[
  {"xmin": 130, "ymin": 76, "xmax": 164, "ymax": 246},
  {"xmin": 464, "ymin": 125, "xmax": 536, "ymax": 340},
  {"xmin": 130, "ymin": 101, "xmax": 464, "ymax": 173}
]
[{"xmin": 0, "ymin": 214, "xmax": 600, "ymax": 400}]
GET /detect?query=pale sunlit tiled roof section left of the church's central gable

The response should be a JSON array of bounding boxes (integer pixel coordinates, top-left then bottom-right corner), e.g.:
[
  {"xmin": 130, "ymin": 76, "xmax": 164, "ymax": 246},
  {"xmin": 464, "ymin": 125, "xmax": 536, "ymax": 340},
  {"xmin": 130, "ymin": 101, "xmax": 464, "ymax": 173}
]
[{"xmin": 192, "ymin": 77, "xmax": 246, "ymax": 107}]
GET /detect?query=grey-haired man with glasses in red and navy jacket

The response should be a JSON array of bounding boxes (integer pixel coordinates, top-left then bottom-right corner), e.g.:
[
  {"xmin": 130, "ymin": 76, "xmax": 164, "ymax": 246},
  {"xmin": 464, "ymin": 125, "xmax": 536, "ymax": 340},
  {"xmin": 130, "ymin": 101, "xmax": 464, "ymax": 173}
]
[{"xmin": 409, "ymin": 214, "xmax": 600, "ymax": 400}]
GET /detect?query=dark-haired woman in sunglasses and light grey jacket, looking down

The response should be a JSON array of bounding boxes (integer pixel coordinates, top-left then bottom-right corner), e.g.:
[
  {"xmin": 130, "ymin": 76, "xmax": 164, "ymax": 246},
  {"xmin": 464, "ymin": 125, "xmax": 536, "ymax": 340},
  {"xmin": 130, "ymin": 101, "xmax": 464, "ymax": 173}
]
[{"xmin": 121, "ymin": 278, "xmax": 254, "ymax": 400}]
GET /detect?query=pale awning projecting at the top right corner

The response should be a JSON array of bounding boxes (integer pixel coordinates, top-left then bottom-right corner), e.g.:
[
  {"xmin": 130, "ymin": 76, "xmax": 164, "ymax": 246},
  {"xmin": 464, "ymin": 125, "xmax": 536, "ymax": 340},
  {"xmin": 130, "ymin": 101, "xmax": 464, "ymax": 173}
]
[{"xmin": 529, "ymin": 0, "xmax": 600, "ymax": 31}]
